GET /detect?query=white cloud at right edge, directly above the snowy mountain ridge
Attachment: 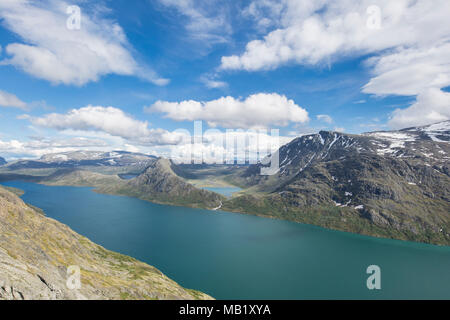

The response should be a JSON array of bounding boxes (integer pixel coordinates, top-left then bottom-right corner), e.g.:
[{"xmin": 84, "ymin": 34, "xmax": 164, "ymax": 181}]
[{"xmin": 363, "ymin": 42, "xmax": 450, "ymax": 129}]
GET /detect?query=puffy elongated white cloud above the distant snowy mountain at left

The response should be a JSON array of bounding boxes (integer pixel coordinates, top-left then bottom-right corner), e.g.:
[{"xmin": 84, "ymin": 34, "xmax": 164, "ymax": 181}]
[{"xmin": 28, "ymin": 105, "xmax": 185, "ymax": 145}]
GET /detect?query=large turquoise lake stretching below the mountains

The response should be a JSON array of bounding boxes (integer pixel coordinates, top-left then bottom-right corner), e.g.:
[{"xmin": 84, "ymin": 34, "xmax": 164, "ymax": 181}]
[{"xmin": 4, "ymin": 182, "xmax": 450, "ymax": 299}]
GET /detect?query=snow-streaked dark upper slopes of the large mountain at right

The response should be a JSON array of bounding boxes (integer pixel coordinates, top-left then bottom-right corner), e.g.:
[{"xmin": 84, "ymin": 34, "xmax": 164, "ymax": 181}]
[{"xmin": 243, "ymin": 121, "xmax": 450, "ymax": 189}]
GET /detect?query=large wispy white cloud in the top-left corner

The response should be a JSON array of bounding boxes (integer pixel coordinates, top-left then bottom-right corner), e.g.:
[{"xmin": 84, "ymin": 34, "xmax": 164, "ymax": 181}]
[{"xmin": 0, "ymin": 0, "xmax": 167, "ymax": 85}]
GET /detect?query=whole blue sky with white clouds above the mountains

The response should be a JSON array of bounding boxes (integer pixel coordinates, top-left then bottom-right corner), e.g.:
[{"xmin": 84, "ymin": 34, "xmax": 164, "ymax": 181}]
[{"xmin": 0, "ymin": 0, "xmax": 450, "ymax": 160}]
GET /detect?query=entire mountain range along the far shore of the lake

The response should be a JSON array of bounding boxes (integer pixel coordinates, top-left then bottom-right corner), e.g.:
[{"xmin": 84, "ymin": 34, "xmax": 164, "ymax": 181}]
[{"xmin": 0, "ymin": 121, "xmax": 450, "ymax": 245}]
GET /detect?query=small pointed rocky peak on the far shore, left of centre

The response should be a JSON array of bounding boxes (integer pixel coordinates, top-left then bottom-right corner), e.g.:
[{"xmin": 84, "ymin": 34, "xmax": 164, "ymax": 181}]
[{"xmin": 103, "ymin": 158, "xmax": 225, "ymax": 209}]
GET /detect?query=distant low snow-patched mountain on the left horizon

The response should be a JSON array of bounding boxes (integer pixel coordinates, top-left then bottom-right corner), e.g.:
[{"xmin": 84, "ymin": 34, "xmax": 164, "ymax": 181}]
[{"xmin": 3, "ymin": 151, "xmax": 156, "ymax": 170}]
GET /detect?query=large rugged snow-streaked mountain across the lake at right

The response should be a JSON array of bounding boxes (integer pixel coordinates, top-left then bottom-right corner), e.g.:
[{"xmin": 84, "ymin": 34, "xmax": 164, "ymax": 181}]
[{"xmin": 223, "ymin": 121, "xmax": 450, "ymax": 245}]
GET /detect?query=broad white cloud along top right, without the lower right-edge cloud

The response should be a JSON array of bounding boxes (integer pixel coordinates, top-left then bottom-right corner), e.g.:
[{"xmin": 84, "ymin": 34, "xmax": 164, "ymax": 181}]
[{"xmin": 222, "ymin": 0, "xmax": 450, "ymax": 71}]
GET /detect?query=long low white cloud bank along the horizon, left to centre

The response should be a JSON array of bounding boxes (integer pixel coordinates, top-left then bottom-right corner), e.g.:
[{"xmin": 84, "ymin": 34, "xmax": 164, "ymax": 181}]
[{"xmin": 5, "ymin": 106, "xmax": 294, "ymax": 163}]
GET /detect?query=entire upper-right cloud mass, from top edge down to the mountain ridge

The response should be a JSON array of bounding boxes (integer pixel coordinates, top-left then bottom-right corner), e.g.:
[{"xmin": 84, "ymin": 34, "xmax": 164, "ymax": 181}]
[{"xmin": 220, "ymin": 0, "xmax": 450, "ymax": 127}]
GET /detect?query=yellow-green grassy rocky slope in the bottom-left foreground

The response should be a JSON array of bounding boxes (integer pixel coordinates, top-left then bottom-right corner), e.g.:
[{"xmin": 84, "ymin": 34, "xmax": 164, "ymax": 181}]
[{"xmin": 0, "ymin": 187, "xmax": 211, "ymax": 300}]
